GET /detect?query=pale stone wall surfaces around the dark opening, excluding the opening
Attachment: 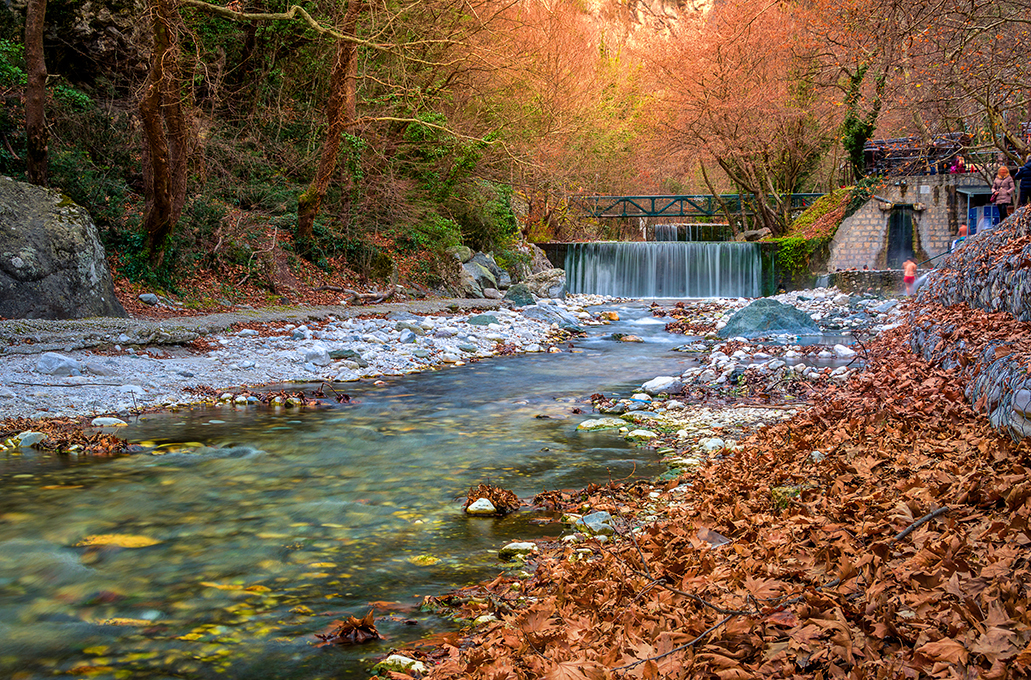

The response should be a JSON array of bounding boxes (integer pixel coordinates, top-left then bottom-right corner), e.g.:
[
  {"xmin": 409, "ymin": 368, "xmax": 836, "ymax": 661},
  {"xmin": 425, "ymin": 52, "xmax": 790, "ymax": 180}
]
[{"xmin": 828, "ymin": 174, "xmax": 985, "ymax": 272}]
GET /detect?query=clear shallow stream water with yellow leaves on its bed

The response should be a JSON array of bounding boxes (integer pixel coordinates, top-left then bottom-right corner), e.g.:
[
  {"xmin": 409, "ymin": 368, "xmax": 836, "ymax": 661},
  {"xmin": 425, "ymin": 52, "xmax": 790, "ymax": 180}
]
[{"xmin": 0, "ymin": 306, "xmax": 693, "ymax": 680}]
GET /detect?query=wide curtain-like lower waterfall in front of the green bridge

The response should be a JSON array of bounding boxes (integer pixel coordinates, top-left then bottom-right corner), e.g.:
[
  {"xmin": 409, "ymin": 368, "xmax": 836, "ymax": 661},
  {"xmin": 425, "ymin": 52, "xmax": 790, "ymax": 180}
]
[{"xmin": 565, "ymin": 241, "xmax": 762, "ymax": 298}]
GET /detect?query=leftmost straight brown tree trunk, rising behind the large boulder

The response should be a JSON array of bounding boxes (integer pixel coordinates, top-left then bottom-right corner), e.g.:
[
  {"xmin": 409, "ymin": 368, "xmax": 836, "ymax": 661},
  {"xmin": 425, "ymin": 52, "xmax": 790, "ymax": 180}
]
[{"xmin": 25, "ymin": 0, "xmax": 48, "ymax": 186}]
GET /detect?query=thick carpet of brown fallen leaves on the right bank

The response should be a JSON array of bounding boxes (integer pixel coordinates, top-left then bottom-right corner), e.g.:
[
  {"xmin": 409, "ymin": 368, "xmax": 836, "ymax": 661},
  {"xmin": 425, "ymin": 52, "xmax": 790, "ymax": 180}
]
[{"xmin": 394, "ymin": 309, "xmax": 1031, "ymax": 680}]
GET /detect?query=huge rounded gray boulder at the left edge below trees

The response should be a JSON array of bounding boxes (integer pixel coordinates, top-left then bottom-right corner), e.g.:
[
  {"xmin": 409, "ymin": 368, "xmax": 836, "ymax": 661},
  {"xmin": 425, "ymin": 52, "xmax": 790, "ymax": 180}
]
[{"xmin": 0, "ymin": 177, "xmax": 128, "ymax": 318}]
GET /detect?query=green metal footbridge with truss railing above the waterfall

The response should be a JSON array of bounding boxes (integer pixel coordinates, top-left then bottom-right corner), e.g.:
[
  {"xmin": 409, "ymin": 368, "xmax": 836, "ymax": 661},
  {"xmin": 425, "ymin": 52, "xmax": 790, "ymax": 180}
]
[{"xmin": 569, "ymin": 194, "xmax": 823, "ymax": 217}]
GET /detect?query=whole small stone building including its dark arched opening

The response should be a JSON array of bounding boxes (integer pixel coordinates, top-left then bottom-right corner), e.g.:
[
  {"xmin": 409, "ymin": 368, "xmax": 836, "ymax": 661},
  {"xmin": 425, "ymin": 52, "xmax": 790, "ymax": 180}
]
[{"xmin": 827, "ymin": 173, "xmax": 991, "ymax": 272}]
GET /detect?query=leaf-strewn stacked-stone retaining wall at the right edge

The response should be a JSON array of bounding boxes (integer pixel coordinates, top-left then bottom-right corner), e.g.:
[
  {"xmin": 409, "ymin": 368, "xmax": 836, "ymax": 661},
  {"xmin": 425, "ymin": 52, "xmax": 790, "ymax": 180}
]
[{"xmin": 910, "ymin": 208, "xmax": 1031, "ymax": 439}]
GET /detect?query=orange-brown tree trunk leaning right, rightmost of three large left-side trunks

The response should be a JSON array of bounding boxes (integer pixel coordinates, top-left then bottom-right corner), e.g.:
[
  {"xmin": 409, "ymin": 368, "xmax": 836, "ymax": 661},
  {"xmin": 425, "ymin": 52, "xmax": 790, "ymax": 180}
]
[{"xmin": 296, "ymin": 0, "xmax": 362, "ymax": 254}]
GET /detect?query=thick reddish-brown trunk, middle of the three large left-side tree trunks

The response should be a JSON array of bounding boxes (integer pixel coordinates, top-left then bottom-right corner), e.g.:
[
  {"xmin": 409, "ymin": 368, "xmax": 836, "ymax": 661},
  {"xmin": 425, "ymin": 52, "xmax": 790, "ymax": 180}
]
[{"xmin": 139, "ymin": 0, "xmax": 188, "ymax": 268}]
